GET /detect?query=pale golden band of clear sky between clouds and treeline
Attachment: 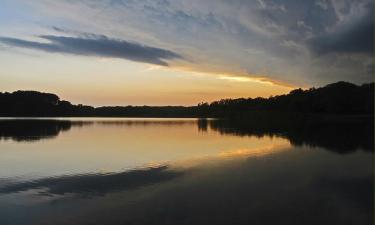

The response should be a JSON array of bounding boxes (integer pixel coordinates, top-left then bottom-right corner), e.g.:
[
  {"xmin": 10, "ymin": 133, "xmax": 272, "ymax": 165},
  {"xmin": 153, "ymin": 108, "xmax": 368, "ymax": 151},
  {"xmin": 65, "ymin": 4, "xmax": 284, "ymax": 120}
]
[{"xmin": 0, "ymin": 53, "xmax": 292, "ymax": 106}]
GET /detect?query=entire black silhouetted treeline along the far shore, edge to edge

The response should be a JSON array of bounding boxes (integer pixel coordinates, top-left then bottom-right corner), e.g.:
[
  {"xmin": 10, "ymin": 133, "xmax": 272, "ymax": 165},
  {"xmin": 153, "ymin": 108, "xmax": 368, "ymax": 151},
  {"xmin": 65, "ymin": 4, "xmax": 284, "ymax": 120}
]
[{"xmin": 0, "ymin": 82, "xmax": 374, "ymax": 117}]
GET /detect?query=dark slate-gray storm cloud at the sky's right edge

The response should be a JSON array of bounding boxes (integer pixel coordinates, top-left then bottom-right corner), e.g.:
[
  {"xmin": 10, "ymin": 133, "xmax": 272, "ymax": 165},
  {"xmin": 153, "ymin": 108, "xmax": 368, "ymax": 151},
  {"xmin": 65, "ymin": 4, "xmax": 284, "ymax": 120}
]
[{"xmin": 308, "ymin": 4, "xmax": 374, "ymax": 54}]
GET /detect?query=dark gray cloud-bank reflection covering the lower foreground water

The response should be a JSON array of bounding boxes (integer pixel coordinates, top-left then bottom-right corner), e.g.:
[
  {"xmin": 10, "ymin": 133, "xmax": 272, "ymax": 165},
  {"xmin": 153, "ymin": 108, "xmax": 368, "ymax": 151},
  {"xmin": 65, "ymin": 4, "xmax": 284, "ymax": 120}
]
[{"xmin": 0, "ymin": 145, "xmax": 374, "ymax": 225}]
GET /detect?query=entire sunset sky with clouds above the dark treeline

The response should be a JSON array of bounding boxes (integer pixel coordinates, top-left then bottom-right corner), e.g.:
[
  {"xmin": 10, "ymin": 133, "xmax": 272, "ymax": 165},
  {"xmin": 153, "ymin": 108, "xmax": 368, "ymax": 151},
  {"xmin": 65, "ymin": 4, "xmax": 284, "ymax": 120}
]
[{"xmin": 0, "ymin": 0, "xmax": 374, "ymax": 106}]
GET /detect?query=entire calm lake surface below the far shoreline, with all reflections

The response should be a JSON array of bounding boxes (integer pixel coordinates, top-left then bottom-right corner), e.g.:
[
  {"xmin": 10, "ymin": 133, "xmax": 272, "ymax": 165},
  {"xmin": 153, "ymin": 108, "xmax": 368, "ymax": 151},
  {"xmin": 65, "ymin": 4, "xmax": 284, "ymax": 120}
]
[{"xmin": 0, "ymin": 118, "xmax": 374, "ymax": 225}]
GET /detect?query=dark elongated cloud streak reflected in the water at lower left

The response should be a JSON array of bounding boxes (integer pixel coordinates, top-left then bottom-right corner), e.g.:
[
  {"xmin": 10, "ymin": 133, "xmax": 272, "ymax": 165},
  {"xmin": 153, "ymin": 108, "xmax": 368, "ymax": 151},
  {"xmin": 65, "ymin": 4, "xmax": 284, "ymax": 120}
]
[{"xmin": 0, "ymin": 166, "xmax": 182, "ymax": 197}]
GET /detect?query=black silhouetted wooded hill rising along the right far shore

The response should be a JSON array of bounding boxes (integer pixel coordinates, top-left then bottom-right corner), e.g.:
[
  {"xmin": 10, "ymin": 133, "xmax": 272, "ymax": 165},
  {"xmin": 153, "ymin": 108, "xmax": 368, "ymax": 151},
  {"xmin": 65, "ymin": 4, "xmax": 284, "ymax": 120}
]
[{"xmin": 198, "ymin": 82, "xmax": 374, "ymax": 117}]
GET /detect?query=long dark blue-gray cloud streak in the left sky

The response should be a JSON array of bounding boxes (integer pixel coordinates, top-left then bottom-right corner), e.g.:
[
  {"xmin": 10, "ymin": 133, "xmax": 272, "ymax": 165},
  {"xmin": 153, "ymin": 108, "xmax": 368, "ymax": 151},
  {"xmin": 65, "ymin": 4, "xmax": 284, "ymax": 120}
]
[{"xmin": 0, "ymin": 34, "xmax": 183, "ymax": 66}]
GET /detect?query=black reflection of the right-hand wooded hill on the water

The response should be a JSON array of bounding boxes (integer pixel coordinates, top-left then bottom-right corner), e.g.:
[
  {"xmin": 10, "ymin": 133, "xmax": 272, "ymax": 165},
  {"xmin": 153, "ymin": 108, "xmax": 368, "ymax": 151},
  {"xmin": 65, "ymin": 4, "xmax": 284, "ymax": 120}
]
[{"xmin": 209, "ymin": 115, "xmax": 374, "ymax": 153}]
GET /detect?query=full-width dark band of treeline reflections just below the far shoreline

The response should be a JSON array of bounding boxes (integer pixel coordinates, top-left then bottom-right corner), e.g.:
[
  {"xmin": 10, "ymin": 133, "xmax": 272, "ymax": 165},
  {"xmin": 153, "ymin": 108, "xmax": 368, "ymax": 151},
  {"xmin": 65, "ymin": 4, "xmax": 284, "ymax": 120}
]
[{"xmin": 0, "ymin": 118, "xmax": 374, "ymax": 153}]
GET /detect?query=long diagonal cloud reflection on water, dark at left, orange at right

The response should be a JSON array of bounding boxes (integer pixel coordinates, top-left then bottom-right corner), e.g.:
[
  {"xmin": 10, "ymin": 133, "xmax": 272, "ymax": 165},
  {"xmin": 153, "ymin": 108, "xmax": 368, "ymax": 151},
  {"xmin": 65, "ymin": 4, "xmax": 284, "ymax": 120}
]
[{"xmin": 0, "ymin": 139, "xmax": 290, "ymax": 197}]
